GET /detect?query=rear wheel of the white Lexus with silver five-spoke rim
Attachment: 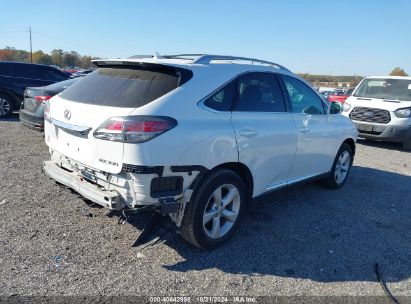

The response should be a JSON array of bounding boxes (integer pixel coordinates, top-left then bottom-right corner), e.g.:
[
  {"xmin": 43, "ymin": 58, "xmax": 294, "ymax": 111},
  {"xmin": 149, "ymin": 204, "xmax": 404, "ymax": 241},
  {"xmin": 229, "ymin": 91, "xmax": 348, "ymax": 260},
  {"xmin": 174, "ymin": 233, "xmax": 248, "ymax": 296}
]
[{"xmin": 181, "ymin": 169, "xmax": 247, "ymax": 249}]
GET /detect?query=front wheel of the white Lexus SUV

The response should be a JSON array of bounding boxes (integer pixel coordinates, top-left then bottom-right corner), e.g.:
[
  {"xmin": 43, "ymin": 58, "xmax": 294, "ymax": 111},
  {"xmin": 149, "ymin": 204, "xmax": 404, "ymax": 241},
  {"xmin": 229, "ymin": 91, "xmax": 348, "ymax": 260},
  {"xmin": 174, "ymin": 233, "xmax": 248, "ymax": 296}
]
[{"xmin": 321, "ymin": 143, "xmax": 353, "ymax": 189}]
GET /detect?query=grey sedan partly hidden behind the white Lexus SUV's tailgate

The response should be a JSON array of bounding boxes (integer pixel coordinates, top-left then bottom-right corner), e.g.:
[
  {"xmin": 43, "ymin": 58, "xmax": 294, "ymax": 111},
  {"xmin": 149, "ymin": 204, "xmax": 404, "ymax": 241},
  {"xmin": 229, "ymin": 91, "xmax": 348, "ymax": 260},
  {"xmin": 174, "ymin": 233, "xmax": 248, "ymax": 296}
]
[{"xmin": 19, "ymin": 78, "xmax": 79, "ymax": 131}]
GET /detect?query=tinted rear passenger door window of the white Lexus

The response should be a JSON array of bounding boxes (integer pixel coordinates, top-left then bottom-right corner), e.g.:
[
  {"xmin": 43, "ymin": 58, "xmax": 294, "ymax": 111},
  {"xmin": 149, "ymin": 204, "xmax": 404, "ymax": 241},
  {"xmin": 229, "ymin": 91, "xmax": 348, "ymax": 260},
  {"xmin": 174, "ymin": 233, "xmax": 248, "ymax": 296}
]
[{"xmin": 235, "ymin": 73, "xmax": 285, "ymax": 112}]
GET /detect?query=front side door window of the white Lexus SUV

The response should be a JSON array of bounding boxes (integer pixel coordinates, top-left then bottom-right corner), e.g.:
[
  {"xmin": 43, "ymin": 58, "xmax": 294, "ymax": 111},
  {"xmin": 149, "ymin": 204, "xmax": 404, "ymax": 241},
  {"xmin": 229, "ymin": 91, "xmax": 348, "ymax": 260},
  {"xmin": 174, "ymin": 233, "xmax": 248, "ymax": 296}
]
[{"xmin": 281, "ymin": 76, "xmax": 324, "ymax": 114}]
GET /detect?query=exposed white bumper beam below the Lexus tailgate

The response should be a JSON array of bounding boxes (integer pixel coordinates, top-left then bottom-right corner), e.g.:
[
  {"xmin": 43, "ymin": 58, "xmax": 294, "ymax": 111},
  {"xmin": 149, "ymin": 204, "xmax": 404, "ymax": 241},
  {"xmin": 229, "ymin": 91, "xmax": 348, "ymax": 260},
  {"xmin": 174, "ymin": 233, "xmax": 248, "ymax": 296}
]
[{"xmin": 43, "ymin": 161, "xmax": 124, "ymax": 210}]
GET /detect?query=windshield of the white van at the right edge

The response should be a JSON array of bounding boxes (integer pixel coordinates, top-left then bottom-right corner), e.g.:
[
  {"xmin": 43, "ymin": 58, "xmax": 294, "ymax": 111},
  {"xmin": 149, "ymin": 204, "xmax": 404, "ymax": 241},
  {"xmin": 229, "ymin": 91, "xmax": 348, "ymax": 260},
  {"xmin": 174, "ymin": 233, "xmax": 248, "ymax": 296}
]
[{"xmin": 354, "ymin": 78, "xmax": 411, "ymax": 101}]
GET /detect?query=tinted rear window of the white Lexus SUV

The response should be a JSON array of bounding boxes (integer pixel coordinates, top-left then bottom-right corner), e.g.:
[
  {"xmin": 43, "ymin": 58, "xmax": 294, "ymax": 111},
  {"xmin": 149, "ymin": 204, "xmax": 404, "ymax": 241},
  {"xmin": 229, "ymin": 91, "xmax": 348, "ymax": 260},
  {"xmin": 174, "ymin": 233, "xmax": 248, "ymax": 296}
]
[{"xmin": 61, "ymin": 66, "xmax": 192, "ymax": 108}]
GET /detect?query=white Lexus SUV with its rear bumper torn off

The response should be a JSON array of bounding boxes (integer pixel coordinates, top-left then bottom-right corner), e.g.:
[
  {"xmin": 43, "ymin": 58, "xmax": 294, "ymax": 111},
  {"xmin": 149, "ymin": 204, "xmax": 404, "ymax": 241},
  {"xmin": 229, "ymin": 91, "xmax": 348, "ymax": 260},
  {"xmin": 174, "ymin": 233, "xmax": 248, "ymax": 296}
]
[{"xmin": 43, "ymin": 55, "xmax": 357, "ymax": 249}]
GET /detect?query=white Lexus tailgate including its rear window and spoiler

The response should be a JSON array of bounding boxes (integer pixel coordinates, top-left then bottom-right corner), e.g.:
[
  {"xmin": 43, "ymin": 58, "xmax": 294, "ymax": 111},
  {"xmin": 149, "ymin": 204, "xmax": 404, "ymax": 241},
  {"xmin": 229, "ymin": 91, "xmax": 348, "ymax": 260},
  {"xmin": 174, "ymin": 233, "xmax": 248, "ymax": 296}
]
[{"xmin": 45, "ymin": 62, "xmax": 191, "ymax": 173}]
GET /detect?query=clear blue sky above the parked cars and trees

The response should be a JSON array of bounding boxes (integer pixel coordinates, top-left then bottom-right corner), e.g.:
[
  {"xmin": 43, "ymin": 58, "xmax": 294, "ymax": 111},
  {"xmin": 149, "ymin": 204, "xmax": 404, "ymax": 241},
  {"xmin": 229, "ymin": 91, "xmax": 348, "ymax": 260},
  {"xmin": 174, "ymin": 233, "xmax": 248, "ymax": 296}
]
[{"xmin": 0, "ymin": 0, "xmax": 411, "ymax": 76}]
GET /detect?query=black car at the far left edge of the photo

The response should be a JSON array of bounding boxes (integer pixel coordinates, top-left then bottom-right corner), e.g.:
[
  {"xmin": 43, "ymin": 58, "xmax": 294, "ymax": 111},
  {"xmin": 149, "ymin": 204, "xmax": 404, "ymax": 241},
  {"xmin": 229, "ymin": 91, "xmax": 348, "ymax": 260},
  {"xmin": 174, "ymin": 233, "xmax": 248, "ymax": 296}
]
[{"xmin": 0, "ymin": 61, "xmax": 69, "ymax": 117}]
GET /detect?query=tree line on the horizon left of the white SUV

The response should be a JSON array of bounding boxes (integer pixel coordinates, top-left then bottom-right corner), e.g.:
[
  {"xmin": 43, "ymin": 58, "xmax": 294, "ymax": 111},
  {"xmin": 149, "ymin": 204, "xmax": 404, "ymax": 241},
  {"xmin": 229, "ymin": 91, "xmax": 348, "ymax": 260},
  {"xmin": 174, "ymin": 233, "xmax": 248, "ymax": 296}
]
[{"xmin": 0, "ymin": 47, "xmax": 98, "ymax": 69}]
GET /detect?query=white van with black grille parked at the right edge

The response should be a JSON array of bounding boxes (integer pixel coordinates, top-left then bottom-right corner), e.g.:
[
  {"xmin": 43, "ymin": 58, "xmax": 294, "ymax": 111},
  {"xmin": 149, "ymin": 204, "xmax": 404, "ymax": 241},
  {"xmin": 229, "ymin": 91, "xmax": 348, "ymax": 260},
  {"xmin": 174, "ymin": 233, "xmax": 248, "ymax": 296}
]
[{"xmin": 343, "ymin": 76, "xmax": 411, "ymax": 150}]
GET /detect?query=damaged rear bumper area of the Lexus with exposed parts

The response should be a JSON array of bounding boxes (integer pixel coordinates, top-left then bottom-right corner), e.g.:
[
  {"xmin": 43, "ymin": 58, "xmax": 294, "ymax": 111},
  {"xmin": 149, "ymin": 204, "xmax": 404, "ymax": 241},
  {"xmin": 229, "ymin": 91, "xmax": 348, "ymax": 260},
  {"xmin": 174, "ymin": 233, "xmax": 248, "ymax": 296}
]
[{"xmin": 43, "ymin": 150, "xmax": 204, "ymax": 214}]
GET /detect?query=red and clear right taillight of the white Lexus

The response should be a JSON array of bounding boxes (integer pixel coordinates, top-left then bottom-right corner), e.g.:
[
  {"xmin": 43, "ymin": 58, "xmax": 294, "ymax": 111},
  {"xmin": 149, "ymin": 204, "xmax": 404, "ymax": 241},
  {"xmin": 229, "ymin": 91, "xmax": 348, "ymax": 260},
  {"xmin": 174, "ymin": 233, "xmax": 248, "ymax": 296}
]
[{"xmin": 93, "ymin": 116, "xmax": 177, "ymax": 143}]
